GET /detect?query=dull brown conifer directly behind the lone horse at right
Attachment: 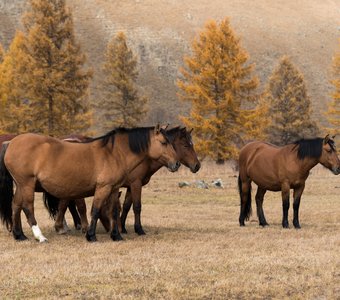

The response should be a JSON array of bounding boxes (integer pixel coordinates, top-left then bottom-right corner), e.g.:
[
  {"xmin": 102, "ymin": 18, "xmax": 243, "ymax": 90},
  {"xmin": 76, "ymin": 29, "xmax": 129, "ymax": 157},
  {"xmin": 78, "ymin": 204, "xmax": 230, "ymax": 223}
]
[{"xmin": 265, "ymin": 56, "xmax": 319, "ymax": 145}]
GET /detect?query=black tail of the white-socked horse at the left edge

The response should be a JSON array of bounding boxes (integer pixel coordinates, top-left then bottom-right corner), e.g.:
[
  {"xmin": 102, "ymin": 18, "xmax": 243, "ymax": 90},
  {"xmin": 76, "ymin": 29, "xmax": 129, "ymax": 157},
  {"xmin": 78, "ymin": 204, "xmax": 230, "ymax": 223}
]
[{"xmin": 0, "ymin": 143, "xmax": 13, "ymax": 231}]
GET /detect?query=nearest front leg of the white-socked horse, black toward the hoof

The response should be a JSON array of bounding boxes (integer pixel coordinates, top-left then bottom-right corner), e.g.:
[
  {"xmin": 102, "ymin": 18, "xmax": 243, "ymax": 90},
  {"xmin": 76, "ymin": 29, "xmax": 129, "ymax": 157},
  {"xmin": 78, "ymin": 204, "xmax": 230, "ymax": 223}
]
[{"xmin": 86, "ymin": 185, "xmax": 112, "ymax": 242}]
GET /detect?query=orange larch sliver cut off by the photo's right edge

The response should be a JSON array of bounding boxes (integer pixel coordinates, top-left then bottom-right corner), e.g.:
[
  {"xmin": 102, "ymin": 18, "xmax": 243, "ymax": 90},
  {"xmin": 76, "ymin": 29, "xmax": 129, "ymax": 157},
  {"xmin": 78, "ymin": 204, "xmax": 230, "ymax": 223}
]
[{"xmin": 327, "ymin": 41, "xmax": 340, "ymax": 134}]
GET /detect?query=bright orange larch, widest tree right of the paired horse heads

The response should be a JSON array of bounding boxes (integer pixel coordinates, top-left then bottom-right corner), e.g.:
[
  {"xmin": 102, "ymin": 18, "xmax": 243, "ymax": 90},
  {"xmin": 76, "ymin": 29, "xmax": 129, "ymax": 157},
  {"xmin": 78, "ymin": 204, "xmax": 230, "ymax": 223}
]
[{"xmin": 178, "ymin": 19, "xmax": 258, "ymax": 163}]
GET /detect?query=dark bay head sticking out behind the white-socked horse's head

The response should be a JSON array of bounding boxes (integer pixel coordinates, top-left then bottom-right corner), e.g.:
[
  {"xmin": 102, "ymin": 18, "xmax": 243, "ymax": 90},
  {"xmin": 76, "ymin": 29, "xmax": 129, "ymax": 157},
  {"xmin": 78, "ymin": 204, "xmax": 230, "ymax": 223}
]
[{"xmin": 167, "ymin": 127, "xmax": 201, "ymax": 173}]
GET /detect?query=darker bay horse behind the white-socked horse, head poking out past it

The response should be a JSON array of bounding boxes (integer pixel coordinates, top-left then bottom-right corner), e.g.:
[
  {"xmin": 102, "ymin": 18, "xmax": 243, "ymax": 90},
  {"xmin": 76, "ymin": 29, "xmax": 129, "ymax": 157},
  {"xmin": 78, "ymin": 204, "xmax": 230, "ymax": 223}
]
[{"xmin": 46, "ymin": 126, "xmax": 201, "ymax": 235}]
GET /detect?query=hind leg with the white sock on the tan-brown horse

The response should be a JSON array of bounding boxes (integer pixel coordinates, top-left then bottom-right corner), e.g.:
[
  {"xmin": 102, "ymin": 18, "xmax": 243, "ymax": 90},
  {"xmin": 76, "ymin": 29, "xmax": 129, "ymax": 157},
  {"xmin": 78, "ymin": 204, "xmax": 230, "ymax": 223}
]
[{"xmin": 21, "ymin": 183, "xmax": 47, "ymax": 243}]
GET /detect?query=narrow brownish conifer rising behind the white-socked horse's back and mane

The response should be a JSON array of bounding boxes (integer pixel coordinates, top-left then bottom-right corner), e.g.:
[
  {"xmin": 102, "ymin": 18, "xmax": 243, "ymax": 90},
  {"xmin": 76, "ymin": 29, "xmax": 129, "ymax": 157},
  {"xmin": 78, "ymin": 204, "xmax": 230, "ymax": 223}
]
[{"xmin": 98, "ymin": 32, "xmax": 147, "ymax": 130}]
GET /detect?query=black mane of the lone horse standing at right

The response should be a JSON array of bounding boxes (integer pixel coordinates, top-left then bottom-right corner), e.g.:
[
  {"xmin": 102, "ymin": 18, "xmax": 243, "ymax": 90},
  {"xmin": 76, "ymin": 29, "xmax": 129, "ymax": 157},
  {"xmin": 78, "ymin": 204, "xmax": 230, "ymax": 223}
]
[{"xmin": 294, "ymin": 138, "xmax": 335, "ymax": 160}]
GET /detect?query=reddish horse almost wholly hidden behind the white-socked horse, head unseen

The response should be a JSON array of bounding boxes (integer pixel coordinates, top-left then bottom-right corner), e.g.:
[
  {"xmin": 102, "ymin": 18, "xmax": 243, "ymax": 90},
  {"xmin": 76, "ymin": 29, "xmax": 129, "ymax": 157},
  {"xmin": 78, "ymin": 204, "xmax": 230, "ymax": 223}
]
[{"xmin": 0, "ymin": 134, "xmax": 90, "ymax": 232}]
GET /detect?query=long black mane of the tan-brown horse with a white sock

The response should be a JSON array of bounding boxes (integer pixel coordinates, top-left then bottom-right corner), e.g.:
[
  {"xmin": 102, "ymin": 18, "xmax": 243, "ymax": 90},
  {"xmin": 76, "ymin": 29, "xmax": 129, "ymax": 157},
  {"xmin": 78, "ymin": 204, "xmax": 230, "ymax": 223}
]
[{"xmin": 84, "ymin": 127, "xmax": 154, "ymax": 154}]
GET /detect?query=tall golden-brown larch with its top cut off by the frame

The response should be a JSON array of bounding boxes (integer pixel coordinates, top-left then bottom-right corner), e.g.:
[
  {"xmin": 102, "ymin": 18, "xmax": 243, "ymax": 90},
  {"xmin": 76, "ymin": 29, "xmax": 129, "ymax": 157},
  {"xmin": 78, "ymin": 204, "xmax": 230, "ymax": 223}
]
[{"xmin": 16, "ymin": 0, "xmax": 92, "ymax": 136}]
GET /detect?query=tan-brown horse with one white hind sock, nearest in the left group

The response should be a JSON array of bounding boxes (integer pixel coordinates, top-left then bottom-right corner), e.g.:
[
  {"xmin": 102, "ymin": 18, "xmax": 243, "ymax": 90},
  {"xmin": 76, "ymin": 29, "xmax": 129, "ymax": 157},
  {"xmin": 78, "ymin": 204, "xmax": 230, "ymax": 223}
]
[{"xmin": 0, "ymin": 125, "xmax": 180, "ymax": 242}]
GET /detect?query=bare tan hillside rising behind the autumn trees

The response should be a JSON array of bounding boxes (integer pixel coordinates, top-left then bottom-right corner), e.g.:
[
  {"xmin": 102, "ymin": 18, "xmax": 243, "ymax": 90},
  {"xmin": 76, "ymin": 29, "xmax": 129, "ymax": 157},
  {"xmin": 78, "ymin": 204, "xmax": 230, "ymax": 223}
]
[{"xmin": 0, "ymin": 0, "xmax": 340, "ymax": 129}]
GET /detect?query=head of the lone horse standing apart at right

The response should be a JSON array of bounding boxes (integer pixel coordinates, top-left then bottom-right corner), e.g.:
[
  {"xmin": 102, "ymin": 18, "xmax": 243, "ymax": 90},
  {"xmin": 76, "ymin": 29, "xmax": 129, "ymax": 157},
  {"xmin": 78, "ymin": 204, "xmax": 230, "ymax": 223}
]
[{"xmin": 320, "ymin": 134, "xmax": 340, "ymax": 175}]
